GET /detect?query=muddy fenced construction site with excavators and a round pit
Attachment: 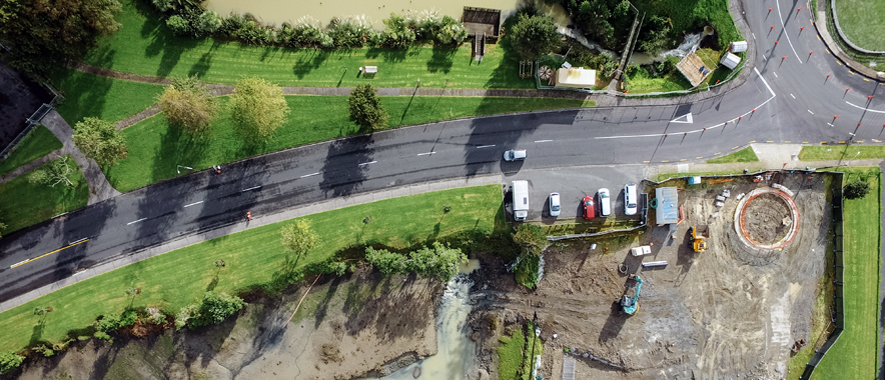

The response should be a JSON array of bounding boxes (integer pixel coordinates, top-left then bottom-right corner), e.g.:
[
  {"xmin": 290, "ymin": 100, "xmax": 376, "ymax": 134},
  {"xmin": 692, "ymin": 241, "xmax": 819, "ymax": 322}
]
[{"xmin": 469, "ymin": 171, "xmax": 833, "ymax": 380}]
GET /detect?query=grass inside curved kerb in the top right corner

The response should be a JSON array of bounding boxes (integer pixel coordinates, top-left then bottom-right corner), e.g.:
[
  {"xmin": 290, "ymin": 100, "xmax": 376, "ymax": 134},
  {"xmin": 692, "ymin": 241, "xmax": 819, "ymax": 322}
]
[{"xmin": 836, "ymin": 0, "xmax": 885, "ymax": 51}]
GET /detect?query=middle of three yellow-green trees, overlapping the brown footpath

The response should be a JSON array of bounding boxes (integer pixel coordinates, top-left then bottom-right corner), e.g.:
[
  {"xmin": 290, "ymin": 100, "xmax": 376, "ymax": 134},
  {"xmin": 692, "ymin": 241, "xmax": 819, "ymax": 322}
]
[{"xmin": 157, "ymin": 76, "xmax": 218, "ymax": 133}]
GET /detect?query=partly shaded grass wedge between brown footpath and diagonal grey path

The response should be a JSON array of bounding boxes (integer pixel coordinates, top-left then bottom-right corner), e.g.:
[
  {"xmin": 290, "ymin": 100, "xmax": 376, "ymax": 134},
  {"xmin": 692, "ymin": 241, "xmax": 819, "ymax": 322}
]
[{"xmin": 52, "ymin": 68, "xmax": 164, "ymax": 125}]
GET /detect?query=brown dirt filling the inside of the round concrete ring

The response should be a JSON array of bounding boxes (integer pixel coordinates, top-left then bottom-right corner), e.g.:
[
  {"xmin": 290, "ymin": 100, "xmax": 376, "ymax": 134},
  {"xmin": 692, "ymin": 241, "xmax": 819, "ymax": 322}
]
[{"xmin": 744, "ymin": 193, "xmax": 793, "ymax": 245}]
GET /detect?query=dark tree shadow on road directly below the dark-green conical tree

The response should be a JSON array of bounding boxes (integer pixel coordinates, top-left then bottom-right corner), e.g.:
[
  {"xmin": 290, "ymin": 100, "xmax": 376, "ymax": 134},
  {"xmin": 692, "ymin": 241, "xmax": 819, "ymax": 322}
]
[{"xmin": 320, "ymin": 135, "xmax": 375, "ymax": 199}]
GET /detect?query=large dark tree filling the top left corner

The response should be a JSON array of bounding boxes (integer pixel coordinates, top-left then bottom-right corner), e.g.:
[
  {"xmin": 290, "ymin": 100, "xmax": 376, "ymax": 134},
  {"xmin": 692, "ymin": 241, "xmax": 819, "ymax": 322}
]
[{"xmin": 0, "ymin": 0, "xmax": 122, "ymax": 78}]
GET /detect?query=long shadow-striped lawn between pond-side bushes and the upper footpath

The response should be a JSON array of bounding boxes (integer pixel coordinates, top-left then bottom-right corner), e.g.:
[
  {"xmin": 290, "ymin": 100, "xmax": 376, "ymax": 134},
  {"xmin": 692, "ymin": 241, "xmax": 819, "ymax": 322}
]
[{"xmin": 85, "ymin": 0, "xmax": 534, "ymax": 89}]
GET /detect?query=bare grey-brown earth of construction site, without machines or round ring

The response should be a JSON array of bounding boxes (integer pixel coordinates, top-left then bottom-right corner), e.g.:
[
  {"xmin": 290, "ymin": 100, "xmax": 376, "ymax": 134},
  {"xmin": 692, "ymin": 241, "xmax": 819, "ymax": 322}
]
[{"xmin": 471, "ymin": 174, "xmax": 829, "ymax": 379}]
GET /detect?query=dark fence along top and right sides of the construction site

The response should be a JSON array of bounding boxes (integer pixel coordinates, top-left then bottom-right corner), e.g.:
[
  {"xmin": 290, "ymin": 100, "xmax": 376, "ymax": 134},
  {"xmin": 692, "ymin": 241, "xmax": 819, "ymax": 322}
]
[{"xmin": 650, "ymin": 170, "xmax": 848, "ymax": 380}]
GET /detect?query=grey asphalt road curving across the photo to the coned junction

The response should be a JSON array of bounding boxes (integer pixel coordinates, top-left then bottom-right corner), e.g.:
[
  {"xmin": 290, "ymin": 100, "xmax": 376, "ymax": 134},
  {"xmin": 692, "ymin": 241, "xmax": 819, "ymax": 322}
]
[{"xmin": 0, "ymin": 0, "xmax": 885, "ymax": 301}]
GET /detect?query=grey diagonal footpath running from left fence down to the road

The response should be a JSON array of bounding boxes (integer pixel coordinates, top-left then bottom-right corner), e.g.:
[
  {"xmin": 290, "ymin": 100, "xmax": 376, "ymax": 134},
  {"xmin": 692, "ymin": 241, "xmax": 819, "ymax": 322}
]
[{"xmin": 42, "ymin": 110, "xmax": 120, "ymax": 205}]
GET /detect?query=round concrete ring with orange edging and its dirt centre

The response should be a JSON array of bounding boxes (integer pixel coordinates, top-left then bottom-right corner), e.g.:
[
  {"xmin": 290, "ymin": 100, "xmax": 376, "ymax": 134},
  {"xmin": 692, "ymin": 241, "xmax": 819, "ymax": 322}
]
[{"xmin": 734, "ymin": 188, "xmax": 799, "ymax": 250}]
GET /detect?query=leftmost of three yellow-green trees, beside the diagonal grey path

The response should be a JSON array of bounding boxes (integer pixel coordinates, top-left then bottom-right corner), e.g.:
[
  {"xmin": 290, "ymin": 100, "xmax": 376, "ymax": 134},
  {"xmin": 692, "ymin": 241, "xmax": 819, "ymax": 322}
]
[{"xmin": 73, "ymin": 117, "xmax": 129, "ymax": 165}]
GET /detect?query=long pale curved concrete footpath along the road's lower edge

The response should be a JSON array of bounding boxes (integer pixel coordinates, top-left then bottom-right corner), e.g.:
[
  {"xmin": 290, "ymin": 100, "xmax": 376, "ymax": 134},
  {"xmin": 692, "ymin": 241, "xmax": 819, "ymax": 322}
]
[{"xmin": 0, "ymin": 174, "xmax": 503, "ymax": 312}]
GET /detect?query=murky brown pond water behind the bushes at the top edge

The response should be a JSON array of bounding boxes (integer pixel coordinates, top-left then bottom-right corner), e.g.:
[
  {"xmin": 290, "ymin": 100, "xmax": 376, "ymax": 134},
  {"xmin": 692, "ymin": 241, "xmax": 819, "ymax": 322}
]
[{"xmin": 205, "ymin": 0, "xmax": 568, "ymax": 30}]
